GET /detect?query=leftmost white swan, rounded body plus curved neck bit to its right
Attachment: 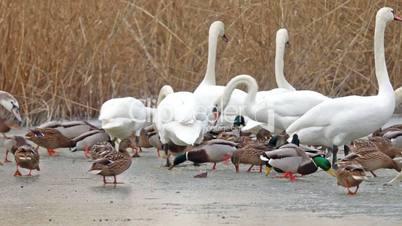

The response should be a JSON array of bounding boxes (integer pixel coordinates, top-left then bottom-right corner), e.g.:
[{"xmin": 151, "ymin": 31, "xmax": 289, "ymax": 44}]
[{"xmin": 99, "ymin": 85, "xmax": 173, "ymax": 139}]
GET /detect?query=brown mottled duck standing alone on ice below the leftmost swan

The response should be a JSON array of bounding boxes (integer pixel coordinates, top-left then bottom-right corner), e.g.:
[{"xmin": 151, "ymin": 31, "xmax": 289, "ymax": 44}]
[{"xmin": 89, "ymin": 139, "xmax": 132, "ymax": 184}]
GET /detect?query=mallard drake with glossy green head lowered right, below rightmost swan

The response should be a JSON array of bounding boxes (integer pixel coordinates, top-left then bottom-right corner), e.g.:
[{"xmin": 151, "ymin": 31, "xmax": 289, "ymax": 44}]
[{"xmin": 260, "ymin": 134, "xmax": 335, "ymax": 181}]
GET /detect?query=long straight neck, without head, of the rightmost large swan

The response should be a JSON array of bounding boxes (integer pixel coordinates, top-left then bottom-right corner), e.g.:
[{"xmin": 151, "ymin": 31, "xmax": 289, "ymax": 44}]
[{"xmin": 374, "ymin": 16, "xmax": 394, "ymax": 96}]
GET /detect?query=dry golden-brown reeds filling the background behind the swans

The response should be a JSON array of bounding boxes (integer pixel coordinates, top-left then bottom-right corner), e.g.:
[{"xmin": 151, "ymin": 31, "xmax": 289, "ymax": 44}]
[{"xmin": 0, "ymin": 0, "xmax": 402, "ymax": 124}]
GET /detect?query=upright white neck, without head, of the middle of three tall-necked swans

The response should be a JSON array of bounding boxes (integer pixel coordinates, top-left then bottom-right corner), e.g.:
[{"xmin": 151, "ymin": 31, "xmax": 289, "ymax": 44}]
[{"xmin": 275, "ymin": 34, "xmax": 296, "ymax": 91}]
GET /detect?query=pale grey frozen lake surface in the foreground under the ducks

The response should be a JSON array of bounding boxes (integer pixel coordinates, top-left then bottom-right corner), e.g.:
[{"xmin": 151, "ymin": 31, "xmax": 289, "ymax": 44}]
[{"xmin": 0, "ymin": 119, "xmax": 402, "ymax": 225}]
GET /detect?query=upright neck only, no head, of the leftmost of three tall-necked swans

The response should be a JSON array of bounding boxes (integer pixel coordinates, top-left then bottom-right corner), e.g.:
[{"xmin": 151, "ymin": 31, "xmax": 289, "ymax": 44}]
[{"xmin": 201, "ymin": 26, "xmax": 219, "ymax": 86}]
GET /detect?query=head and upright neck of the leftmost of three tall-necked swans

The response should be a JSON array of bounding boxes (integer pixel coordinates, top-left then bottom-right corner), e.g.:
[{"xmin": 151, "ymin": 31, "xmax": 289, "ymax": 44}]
[{"xmin": 200, "ymin": 21, "xmax": 225, "ymax": 86}]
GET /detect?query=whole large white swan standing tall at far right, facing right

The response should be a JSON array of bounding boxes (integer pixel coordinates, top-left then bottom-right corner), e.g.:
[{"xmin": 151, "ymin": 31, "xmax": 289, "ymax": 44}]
[{"xmin": 286, "ymin": 7, "xmax": 401, "ymax": 166}]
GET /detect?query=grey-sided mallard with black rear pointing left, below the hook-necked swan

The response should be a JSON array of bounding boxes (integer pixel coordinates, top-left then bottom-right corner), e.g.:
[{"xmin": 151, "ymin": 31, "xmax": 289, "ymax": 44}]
[{"xmin": 169, "ymin": 139, "xmax": 237, "ymax": 170}]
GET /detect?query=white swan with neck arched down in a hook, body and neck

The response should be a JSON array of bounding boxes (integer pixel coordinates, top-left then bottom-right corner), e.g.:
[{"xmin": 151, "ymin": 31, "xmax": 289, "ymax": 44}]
[{"xmin": 215, "ymin": 75, "xmax": 329, "ymax": 132}]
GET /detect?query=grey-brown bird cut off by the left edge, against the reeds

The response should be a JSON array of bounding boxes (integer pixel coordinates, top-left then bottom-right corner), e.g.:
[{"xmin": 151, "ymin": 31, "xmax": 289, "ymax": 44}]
[{"xmin": 0, "ymin": 91, "xmax": 22, "ymax": 137}]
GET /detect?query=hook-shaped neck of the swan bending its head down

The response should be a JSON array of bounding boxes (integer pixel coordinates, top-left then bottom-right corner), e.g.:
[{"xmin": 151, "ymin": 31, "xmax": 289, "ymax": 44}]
[{"xmin": 218, "ymin": 75, "xmax": 258, "ymax": 111}]
